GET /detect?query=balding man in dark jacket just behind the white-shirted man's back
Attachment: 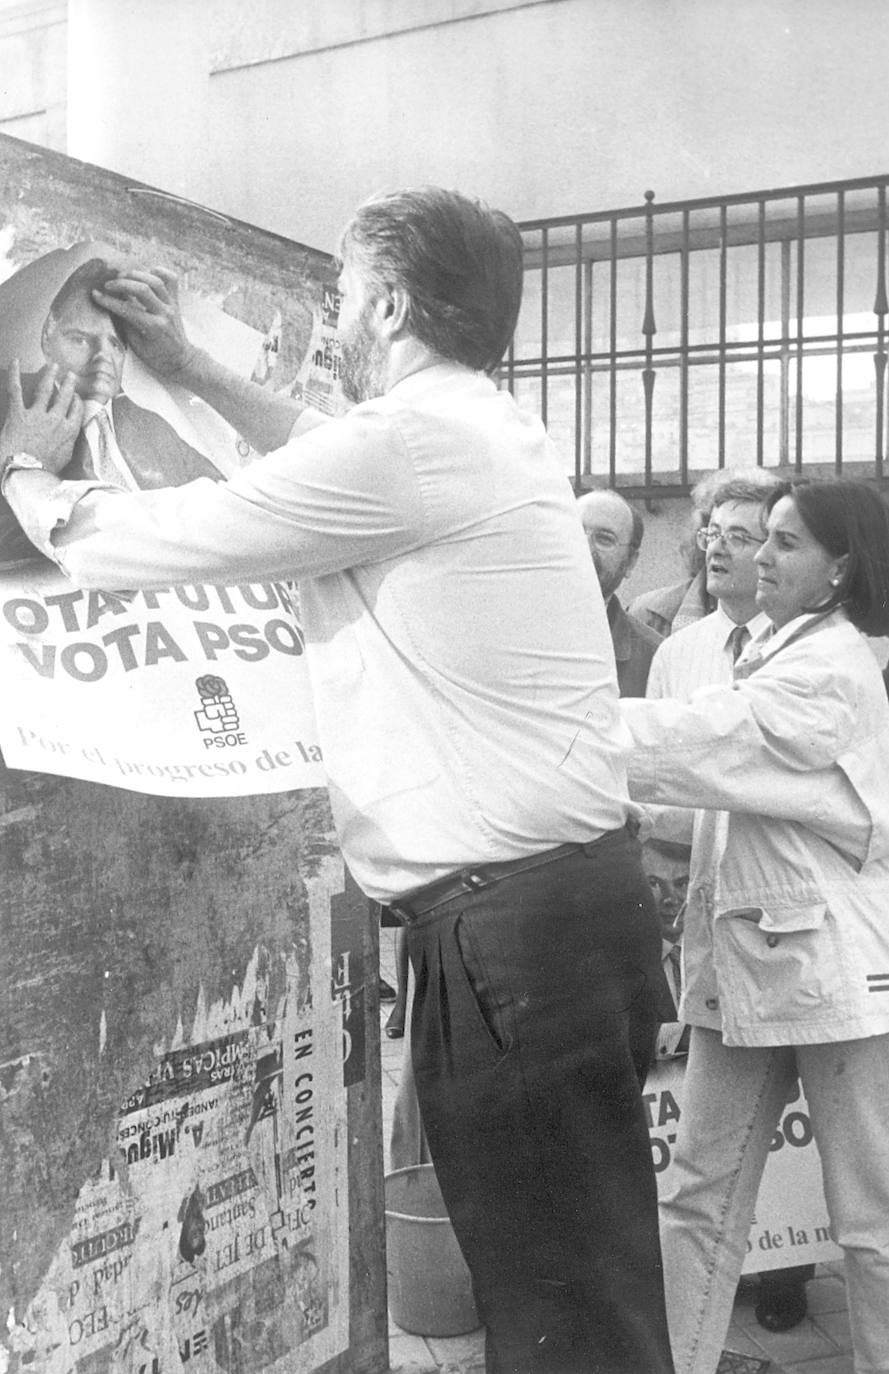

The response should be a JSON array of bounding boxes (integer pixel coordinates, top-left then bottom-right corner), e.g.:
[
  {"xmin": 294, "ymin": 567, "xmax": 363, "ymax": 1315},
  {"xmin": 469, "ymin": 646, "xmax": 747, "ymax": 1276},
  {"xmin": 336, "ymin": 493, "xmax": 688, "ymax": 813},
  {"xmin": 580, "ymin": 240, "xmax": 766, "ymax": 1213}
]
[{"xmin": 577, "ymin": 491, "xmax": 661, "ymax": 697}]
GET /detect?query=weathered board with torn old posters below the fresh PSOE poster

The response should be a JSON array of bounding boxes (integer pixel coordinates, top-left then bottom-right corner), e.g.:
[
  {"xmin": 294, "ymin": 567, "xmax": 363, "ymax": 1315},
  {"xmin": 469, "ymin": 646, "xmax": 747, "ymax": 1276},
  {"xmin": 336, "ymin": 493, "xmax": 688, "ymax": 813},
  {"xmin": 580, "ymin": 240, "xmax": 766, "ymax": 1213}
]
[{"xmin": 0, "ymin": 772, "xmax": 385, "ymax": 1374}]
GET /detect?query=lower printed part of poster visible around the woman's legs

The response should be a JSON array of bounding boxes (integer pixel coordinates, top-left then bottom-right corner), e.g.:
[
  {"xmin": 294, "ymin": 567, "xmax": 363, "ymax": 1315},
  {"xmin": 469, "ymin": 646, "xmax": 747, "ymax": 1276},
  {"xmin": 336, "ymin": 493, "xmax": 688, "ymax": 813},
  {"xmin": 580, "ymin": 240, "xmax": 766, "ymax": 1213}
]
[{"xmin": 643, "ymin": 1058, "xmax": 841, "ymax": 1274}]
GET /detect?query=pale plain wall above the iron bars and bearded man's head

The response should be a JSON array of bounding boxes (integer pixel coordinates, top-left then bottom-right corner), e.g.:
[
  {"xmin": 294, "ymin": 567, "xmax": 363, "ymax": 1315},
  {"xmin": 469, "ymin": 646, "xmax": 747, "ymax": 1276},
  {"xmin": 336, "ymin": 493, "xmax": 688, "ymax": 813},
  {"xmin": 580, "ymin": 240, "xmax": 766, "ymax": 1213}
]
[{"xmin": 59, "ymin": 0, "xmax": 889, "ymax": 249}]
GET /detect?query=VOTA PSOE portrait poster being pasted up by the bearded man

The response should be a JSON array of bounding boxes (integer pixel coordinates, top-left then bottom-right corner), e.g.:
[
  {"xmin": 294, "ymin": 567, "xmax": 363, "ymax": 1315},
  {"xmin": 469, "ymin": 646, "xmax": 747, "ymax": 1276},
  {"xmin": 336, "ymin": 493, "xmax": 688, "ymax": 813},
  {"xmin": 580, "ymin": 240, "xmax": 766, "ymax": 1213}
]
[{"xmin": 0, "ymin": 242, "xmax": 342, "ymax": 797}]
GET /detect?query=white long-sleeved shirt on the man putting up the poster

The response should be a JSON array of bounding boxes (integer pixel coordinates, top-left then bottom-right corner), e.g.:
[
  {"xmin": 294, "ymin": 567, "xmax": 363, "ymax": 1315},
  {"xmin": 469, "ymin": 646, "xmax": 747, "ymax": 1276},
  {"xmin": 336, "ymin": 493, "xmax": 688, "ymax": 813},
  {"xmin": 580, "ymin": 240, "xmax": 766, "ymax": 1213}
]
[{"xmin": 11, "ymin": 364, "xmax": 632, "ymax": 901}]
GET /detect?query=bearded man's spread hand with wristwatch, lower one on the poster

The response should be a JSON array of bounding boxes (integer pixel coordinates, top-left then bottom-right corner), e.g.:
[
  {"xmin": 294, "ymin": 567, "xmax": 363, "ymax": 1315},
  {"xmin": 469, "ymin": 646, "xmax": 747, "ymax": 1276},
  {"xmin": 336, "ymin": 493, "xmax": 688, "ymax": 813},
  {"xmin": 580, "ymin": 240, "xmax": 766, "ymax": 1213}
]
[{"xmin": 0, "ymin": 359, "xmax": 84, "ymax": 473}]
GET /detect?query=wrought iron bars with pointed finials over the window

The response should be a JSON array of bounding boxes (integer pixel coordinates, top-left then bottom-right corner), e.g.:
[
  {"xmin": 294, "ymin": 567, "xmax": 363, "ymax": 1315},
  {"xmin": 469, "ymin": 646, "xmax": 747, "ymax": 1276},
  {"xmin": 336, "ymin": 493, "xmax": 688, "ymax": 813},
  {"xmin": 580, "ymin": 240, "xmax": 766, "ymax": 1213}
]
[{"xmin": 503, "ymin": 174, "xmax": 889, "ymax": 496}]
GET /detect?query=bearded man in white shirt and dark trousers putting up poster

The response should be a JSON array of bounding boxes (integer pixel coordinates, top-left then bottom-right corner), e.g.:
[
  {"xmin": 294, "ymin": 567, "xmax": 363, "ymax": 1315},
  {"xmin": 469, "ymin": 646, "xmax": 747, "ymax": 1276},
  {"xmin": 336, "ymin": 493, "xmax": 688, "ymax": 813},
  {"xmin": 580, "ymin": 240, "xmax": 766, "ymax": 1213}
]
[{"xmin": 0, "ymin": 188, "xmax": 672, "ymax": 1374}]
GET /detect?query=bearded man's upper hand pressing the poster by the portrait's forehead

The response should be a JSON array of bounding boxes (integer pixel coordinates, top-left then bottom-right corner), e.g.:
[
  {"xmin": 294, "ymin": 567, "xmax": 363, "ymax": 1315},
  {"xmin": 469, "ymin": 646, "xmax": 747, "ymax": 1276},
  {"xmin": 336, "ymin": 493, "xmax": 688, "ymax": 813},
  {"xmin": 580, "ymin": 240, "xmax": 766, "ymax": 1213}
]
[{"xmin": 92, "ymin": 267, "xmax": 196, "ymax": 381}]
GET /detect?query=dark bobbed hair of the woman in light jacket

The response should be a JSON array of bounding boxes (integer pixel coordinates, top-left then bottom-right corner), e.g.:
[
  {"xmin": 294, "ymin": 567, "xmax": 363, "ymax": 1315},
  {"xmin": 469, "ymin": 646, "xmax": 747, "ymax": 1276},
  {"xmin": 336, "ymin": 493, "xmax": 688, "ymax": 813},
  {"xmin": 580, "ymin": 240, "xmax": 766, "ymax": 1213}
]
[{"xmin": 765, "ymin": 477, "xmax": 889, "ymax": 635}]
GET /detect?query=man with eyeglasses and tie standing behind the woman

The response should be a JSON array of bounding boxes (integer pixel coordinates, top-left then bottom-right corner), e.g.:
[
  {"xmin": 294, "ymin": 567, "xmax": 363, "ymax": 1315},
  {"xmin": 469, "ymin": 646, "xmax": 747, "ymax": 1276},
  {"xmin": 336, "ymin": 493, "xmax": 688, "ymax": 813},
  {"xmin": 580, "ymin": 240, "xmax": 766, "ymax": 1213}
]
[{"xmin": 646, "ymin": 473, "xmax": 813, "ymax": 1331}]
